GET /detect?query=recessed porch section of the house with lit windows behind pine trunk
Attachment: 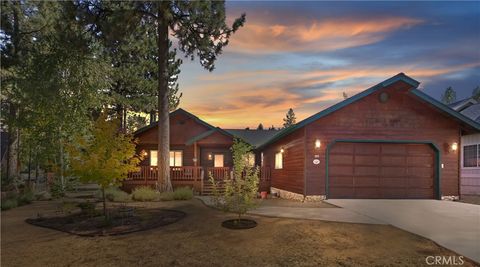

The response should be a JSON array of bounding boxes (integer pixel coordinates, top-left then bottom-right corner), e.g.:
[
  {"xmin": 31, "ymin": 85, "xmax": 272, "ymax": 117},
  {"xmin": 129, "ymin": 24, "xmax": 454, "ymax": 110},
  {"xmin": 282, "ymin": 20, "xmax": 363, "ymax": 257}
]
[{"xmin": 123, "ymin": 108, "xmax": 277, "ymax": 193}]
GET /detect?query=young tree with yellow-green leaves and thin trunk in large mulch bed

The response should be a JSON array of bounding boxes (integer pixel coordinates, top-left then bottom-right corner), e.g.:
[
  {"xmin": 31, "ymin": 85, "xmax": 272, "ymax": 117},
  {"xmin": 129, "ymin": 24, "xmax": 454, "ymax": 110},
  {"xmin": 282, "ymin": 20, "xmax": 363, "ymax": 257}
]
[{"xmin": 67, "ymin": 114, "xmax": 140, "ymax": 216}]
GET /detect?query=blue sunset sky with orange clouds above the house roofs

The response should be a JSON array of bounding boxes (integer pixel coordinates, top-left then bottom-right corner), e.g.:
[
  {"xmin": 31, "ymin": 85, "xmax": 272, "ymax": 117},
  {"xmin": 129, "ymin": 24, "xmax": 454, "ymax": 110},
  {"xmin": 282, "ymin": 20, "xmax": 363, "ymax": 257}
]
[{"xmin": 179, "ymin": 1, "xmax": 480, "ymax": 128}]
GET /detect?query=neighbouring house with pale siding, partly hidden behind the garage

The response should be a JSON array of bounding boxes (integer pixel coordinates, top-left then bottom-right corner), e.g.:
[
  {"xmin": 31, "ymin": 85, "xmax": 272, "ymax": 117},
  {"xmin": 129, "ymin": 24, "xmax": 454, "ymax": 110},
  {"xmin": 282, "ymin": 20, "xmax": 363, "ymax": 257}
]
[{"xmin": 449, "ymin": 98, "xmax": 480, "ymax": 195}]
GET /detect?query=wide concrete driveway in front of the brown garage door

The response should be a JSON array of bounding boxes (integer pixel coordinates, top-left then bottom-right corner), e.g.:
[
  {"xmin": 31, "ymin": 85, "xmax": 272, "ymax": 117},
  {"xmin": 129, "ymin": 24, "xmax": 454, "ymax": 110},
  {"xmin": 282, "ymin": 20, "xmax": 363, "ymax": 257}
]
[{"xmin": 327, "ymin": 199, "xmax": 480, "ymax": 262}]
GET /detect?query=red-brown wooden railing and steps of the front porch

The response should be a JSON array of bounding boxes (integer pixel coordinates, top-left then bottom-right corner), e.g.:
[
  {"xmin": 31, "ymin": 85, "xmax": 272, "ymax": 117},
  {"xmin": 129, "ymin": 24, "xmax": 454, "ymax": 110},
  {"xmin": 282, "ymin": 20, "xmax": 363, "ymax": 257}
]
[{"xmin": 122, "ymin": 166, "xmax": 271, "ymax": 195}]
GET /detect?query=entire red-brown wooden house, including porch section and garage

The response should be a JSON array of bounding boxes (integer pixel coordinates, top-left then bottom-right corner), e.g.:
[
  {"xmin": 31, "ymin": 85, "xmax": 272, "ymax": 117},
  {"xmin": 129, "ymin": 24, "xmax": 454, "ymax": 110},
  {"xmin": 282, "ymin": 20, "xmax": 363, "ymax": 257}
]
[{"xmin": 124, "ymin": 73, "xmax": 480, "ymax": 199}]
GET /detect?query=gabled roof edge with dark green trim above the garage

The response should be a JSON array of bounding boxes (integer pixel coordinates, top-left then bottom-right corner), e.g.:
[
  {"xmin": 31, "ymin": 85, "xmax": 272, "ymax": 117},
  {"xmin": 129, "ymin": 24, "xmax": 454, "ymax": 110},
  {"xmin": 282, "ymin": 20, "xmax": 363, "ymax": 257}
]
[{"xmin": 261, "ymin": 73, "xmax": 480, "ymax": 151}]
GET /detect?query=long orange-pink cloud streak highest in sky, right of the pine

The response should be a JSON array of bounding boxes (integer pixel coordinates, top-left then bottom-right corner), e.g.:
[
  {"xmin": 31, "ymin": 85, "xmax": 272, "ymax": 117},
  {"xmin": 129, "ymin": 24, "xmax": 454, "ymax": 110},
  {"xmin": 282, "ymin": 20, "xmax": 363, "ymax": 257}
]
[{"xmin": 227, "ymin": 17, "xmax": 423, "ymax": 54}]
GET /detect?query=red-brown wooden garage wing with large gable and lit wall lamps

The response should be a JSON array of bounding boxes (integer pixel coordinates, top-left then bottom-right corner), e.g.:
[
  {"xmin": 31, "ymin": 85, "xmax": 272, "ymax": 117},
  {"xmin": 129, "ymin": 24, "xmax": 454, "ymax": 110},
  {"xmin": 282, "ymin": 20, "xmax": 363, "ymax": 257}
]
[{"xmin": 257, "ymin": 73, "xmax": 480, "ymax": 199}]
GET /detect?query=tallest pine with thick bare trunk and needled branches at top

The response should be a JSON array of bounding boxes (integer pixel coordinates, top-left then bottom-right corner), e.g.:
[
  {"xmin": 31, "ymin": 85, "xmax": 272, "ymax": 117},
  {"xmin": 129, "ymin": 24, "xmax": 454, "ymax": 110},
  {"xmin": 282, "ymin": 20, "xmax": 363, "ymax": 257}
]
[{"xmin": 78, "ymin": 0, "xmax": 245, "ymax": 191}]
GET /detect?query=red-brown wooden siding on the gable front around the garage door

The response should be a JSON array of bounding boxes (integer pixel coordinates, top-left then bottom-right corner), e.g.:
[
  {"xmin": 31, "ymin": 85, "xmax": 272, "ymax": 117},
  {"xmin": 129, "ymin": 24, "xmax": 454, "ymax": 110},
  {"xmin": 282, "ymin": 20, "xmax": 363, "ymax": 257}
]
[{"xmin": 306, "ymin": 82, "xmax": 460, "ymax": 195}]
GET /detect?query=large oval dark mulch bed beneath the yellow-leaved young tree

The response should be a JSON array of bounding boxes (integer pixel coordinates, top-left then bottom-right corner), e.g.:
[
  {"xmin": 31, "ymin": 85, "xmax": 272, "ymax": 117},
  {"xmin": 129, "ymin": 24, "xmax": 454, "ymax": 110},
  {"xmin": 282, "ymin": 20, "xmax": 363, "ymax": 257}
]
[{"xmin": 25, "ymin": 209, "xmax": 186, "ymax": 236}]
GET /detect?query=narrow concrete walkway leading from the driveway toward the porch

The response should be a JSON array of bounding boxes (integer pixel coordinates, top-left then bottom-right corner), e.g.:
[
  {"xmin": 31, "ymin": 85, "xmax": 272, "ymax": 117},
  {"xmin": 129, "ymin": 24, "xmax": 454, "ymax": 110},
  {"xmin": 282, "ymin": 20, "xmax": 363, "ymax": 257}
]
[{"xmin": 197, "ymin": 196, "xmax": 385, "ymax": 224}]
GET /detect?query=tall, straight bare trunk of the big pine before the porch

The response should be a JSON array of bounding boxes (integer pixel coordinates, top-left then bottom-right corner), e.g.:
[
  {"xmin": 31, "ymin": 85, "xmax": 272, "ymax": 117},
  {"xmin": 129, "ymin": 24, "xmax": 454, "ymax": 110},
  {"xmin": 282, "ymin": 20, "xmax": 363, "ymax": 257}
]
[{"xmin": 157, "ymin": 1, "xmax": 173, "ymax": 191}]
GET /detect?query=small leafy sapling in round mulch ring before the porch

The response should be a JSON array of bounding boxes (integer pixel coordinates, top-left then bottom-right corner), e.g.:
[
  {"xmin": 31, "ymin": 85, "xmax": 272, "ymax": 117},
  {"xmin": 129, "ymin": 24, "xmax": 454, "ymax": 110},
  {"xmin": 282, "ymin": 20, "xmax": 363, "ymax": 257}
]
[{"xmin": 210, "ymin": 138, "xmax": 259, "ymax": 221}]
